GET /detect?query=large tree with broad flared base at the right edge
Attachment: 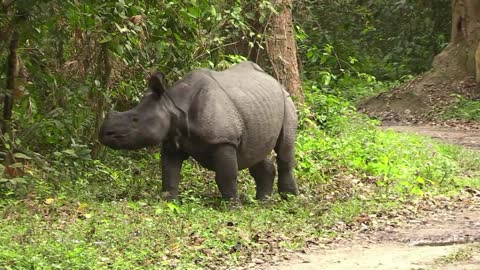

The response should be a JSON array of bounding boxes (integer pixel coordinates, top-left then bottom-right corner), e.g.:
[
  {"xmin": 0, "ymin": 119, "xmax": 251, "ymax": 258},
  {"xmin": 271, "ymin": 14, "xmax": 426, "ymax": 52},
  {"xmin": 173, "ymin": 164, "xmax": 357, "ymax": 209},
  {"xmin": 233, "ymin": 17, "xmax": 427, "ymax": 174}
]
[{"xmin": 361, "ymin": 0, "xmax": 480, "ymax": 120}]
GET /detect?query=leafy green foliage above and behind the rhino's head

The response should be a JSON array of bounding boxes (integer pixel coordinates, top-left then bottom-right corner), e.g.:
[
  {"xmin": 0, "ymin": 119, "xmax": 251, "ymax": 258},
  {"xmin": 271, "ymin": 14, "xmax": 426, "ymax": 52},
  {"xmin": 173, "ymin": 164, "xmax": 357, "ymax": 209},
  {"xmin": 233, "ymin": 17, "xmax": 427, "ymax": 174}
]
[{"xmin": 0, "ymin": 0, "xmax": 272, "ymax": 154}]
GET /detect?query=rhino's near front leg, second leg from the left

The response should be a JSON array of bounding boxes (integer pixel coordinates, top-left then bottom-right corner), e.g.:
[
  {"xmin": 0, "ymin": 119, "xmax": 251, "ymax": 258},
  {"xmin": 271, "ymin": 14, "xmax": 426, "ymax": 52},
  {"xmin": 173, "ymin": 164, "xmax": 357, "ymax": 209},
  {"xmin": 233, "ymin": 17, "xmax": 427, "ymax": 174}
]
[{"xmin": 212, "ymin": 144, "xmax": 238, "ymax": 200}]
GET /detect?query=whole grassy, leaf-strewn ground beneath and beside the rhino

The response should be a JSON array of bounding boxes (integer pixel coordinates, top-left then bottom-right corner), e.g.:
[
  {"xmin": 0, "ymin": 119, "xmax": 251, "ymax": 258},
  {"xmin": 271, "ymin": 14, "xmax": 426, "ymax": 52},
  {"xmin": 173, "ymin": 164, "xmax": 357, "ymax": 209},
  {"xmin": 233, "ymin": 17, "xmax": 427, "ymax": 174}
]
[{"xmin": 0, "ymin": 112, "xmax": 480, "ymax": 269}]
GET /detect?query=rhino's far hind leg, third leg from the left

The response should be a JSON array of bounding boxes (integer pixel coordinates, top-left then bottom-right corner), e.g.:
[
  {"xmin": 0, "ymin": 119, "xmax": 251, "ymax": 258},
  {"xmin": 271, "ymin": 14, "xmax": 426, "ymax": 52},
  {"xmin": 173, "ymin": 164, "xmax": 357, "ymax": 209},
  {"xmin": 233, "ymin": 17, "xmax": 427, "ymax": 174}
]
[{"xmin": 249, "ymin": 158, "xmax": 275, "ymax": 200}]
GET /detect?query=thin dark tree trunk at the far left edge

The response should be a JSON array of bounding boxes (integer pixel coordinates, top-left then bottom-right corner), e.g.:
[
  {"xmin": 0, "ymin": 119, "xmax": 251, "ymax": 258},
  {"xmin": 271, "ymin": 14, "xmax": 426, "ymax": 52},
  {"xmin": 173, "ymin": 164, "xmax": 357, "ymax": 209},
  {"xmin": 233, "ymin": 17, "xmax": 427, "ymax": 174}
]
[{"xmin": 2, "ymin": 30, "xmax": 19, "ymax": 134}]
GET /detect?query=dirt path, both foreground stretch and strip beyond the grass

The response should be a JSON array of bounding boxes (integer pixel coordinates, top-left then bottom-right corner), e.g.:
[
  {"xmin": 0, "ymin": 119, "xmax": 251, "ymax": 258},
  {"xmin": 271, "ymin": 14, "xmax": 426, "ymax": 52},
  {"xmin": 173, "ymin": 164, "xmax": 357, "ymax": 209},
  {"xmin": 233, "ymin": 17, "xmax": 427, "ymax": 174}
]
[{"xmin": 268, "ymin": 122, "xmax": 480, "ymax": 270}]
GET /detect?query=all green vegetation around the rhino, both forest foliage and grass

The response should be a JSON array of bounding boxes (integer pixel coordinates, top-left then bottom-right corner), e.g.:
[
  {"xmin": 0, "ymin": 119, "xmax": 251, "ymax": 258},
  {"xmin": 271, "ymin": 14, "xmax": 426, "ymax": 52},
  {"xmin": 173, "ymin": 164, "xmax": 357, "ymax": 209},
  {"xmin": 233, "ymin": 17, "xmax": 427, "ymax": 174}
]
[{"xmin": 0, "ymin": 0, "xmax": 480, "ymax": 269}]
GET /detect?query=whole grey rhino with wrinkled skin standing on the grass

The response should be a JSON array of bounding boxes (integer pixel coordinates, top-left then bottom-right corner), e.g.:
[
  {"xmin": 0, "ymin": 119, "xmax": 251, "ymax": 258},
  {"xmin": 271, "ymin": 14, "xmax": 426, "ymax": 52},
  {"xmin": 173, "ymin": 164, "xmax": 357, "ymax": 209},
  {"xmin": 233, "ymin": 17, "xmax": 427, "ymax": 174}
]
[{"xmin": 99, "ymin": 62, "xmax": 298, "ymax": 199}]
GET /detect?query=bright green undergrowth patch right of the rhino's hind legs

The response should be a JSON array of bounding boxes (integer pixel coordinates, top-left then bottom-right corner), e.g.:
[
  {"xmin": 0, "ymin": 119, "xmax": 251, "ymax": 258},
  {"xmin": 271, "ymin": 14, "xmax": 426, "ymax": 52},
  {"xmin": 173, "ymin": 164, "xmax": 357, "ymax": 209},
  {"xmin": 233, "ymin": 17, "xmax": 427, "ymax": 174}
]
[{"xmin": 297, "ymin": 113, "xmax": 480, "ymax": 195}]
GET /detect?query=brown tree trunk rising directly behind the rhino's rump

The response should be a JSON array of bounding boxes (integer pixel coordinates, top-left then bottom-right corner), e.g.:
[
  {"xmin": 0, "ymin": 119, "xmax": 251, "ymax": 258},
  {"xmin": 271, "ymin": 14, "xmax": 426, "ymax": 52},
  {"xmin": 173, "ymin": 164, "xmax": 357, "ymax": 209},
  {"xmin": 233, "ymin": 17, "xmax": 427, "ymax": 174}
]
[{"xmin": 267, "ymin": 0, "xmax": 303, "ymax": 103}]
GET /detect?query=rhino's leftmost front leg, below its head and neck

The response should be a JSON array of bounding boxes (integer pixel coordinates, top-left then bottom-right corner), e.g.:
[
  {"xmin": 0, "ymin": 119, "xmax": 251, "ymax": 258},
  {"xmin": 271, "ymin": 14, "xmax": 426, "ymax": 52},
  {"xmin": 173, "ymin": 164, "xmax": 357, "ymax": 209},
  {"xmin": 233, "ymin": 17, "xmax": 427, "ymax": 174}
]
[{"xmin": 161, "ymin": 145, "xmax": 188, "ymax": 200}]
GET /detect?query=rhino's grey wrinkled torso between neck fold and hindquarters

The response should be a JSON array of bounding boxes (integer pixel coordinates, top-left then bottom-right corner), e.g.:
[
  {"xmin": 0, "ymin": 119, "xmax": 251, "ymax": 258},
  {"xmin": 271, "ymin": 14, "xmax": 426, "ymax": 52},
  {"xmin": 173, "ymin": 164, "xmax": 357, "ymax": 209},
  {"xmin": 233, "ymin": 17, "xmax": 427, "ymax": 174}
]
[{"xmin": 190, "ymin": 62, "xmax": 286, "ymax": 169}]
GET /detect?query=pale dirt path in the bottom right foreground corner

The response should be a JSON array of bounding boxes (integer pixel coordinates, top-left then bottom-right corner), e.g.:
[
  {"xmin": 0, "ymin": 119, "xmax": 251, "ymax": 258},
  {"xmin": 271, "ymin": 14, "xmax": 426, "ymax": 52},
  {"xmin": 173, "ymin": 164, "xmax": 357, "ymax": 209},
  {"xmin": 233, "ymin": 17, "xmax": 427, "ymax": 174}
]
[{"xmin": 267, "ymin": 199, "xmax": 480, "ymax": 270}]
